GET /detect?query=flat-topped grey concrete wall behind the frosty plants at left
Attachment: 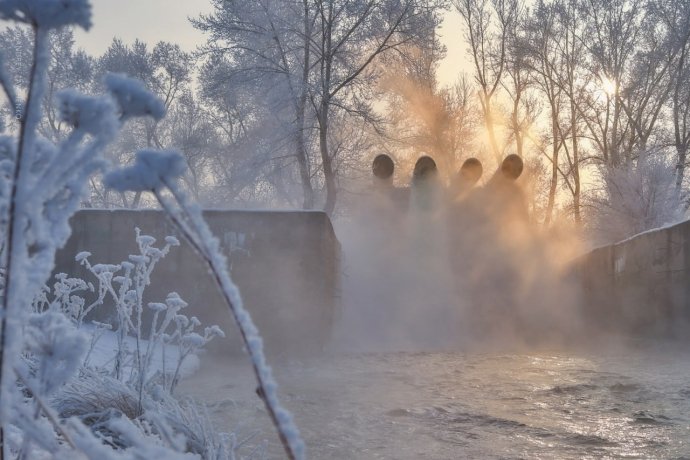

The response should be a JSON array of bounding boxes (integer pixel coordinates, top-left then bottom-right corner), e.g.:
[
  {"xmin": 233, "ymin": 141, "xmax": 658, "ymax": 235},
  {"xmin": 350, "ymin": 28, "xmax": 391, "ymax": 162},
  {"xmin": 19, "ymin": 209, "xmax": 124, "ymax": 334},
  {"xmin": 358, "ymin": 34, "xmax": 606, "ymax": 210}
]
[{"xmin": 55, "ymin": 210, "xmax": 340, "ymax": 356}]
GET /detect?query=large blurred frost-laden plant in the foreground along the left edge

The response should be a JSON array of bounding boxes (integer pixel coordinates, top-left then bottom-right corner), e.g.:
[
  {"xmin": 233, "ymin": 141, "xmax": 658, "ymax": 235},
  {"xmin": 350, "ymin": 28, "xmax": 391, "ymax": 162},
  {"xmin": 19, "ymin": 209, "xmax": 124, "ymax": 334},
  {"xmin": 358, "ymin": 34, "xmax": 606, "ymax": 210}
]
[{"xmin": 0, "ymin": 0, "xmax": 207, "ymax": 458}]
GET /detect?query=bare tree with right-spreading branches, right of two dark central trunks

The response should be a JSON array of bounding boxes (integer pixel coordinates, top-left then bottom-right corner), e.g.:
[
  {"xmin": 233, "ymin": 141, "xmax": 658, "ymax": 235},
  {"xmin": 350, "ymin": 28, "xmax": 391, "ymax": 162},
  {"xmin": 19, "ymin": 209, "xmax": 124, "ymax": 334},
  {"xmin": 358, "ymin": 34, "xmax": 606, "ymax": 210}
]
[{"xmin": 312, "ymin": 0, "xmax": 440, "ymax": 214}]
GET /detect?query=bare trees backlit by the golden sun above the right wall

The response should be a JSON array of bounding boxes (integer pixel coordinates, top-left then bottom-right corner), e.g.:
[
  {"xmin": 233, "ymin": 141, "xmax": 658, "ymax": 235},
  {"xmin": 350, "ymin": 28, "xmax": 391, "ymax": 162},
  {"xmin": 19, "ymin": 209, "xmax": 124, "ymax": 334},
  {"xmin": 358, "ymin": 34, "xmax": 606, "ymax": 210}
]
[{"xmin": 444, "ymin": 0, "xmax": 690, "ymax": 241}]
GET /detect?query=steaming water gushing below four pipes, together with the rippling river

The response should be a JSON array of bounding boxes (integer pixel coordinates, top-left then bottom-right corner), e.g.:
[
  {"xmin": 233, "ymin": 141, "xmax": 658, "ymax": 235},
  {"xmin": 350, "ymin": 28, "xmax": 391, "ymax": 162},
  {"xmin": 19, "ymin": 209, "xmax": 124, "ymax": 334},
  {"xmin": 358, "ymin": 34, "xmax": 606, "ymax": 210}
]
[{"xmin": 181, "ymin": 157, "xmax": 690, "ymax": 460}]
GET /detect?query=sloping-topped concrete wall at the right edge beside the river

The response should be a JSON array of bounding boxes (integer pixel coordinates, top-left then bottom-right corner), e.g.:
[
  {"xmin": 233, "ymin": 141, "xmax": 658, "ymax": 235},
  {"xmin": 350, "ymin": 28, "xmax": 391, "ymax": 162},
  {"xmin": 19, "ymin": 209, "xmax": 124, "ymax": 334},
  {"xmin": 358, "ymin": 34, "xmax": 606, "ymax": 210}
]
[{"xmin": 575, "ymin": 217, "xmax": 690, "ymax": 336}]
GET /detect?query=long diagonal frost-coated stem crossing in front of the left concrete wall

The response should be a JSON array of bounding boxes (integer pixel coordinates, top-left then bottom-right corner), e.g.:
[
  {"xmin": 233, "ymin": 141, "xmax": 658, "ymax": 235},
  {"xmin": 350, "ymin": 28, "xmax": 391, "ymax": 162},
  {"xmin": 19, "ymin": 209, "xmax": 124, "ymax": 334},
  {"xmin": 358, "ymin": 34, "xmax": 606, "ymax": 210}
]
[{"xmin": 152, "ymin": 178, "xmax": 303, "ymax": 460}]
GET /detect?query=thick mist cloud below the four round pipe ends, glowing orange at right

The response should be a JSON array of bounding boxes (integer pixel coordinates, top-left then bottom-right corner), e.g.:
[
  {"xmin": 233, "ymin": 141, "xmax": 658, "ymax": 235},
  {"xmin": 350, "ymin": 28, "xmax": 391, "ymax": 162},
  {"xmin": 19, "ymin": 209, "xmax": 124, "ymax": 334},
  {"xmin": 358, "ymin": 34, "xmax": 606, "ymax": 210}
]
[{"xmin": 335, "ymin": 155, "xmax": 582, "ymax": 351}]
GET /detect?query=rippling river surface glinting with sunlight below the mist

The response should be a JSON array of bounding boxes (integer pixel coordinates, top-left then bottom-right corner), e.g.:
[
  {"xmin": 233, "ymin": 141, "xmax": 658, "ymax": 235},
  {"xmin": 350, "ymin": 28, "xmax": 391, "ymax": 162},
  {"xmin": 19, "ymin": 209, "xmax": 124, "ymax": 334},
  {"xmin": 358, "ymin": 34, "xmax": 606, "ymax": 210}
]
[{"xmin": 181, "ymin": 346, "xmax": 690, "ymax": 460}]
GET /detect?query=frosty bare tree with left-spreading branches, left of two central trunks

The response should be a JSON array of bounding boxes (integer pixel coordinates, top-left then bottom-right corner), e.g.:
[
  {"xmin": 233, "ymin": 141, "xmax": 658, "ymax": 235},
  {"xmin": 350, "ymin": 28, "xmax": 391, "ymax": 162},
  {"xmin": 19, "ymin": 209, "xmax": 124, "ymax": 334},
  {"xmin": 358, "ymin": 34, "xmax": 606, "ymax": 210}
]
[{"xmin": 193, "ymin": 0, "xmax": 316, "ymax": 208}]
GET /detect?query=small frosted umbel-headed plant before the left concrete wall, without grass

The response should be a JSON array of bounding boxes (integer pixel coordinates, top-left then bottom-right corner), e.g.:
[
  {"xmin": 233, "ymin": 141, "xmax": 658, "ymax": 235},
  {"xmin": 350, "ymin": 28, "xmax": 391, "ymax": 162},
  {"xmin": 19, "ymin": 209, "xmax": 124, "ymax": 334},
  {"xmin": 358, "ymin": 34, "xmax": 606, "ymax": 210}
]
[{"xmin": 71, "ymin": 228, "xmax": 225, "ymax": 400}]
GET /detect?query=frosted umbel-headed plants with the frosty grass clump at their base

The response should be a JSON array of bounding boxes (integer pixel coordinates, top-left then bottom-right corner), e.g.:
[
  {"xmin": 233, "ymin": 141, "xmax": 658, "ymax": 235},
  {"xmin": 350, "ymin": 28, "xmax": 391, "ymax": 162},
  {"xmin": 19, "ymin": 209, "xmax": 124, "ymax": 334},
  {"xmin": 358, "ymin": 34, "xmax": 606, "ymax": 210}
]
[{"xmin": 22, "ymin": 229, "xmax": 235, "ymax": 459}]
